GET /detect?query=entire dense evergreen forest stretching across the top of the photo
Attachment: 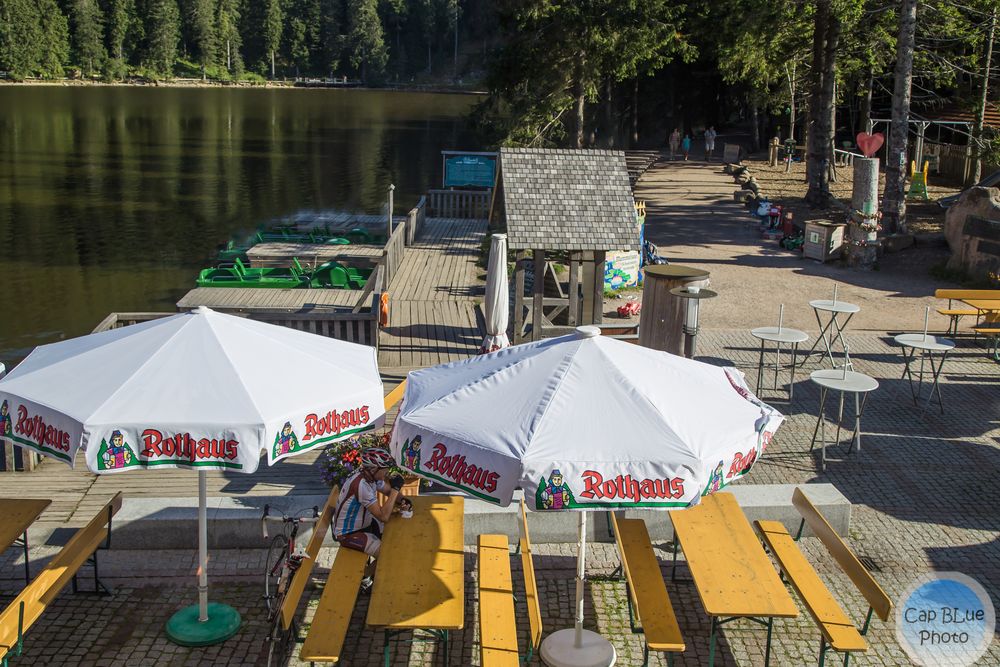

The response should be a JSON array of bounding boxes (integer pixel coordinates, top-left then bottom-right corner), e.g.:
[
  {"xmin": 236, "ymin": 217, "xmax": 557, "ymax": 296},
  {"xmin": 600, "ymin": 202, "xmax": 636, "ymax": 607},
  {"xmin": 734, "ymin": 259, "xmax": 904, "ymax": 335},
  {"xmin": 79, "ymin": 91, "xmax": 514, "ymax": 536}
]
[{"xmin": 0, "ymin": 0, "xmax": 1000, "ymax": 203}]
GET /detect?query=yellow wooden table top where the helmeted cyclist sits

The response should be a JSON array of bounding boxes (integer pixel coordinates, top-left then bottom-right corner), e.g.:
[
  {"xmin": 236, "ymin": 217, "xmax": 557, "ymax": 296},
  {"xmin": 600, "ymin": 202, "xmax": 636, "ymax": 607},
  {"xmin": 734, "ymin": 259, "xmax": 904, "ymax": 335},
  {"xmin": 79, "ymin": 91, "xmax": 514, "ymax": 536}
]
[{"xmin": 368, "ymin": 496, "xmax": 465, "ymax": 630}]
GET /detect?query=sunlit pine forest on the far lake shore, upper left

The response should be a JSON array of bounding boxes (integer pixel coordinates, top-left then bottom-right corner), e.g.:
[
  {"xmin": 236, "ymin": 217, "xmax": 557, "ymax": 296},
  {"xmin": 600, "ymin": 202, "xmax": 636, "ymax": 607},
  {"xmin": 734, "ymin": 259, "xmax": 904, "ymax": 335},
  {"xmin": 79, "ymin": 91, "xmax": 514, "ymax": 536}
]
[{"xmin": 0, "ymin": 0, "xmax": 495, "ymax": 82}]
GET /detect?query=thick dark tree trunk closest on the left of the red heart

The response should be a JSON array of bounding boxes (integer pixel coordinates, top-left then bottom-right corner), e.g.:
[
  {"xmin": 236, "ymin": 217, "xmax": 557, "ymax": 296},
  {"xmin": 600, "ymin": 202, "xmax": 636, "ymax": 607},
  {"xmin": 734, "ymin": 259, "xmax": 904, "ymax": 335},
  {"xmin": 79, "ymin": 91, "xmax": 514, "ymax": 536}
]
[{"xmin": 805, "ymin": 0, "xmax": 840, "ymax": 207}]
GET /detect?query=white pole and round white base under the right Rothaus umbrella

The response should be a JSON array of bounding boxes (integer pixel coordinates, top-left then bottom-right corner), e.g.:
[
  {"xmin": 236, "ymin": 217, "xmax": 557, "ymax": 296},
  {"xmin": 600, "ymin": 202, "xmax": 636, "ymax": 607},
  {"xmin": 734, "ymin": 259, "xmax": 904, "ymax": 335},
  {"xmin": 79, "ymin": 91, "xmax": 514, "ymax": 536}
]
[{"xmin": 539, "ymin": 512, "xmax": 617, "ymax": 667}]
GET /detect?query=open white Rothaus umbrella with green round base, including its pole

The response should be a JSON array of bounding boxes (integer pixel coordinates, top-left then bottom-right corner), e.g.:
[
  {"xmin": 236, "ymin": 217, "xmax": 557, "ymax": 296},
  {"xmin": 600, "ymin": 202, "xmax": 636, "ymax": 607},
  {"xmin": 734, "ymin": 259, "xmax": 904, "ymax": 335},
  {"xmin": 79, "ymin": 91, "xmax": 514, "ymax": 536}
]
[{"xmin": 0, "ymin": 308, "xmax": 385, "ymax": 645}]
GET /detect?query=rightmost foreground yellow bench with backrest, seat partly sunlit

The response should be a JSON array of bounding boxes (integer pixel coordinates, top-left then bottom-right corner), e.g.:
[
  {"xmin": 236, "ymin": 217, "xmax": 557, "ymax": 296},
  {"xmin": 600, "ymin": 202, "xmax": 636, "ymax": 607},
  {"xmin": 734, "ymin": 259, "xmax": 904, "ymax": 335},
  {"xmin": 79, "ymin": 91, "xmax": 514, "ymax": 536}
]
[{"xmin": 755, "ymin": 489, "xmax": 892, "ymax": 667}]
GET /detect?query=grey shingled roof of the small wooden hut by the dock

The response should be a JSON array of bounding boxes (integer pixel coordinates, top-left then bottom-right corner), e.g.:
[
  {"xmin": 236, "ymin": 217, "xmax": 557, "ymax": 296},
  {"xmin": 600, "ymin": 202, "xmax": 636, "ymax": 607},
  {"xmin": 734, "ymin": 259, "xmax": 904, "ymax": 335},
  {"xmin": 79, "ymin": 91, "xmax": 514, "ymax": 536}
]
[{"xmin": 491, "ymin": 148, "xmax": 639, "ymax": 250}]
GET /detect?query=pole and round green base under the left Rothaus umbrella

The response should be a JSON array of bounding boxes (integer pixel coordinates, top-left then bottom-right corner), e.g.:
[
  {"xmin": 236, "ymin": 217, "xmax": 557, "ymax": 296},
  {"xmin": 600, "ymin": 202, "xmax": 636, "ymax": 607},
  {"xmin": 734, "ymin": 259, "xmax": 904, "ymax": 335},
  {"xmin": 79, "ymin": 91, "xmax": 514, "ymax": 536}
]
[{"xmin": 167, "ymin": 469, "xmax": 243, "ymax": 646}]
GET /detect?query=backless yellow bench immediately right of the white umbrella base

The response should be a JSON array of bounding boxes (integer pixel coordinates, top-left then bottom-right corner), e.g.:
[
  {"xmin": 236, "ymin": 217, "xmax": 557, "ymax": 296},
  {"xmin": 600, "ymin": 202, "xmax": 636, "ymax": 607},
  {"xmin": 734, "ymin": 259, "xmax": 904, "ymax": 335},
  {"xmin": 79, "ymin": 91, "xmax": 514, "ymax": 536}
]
[{"xmin": 608, "ymin": 512, "xmax": 685, "ymax": 665}]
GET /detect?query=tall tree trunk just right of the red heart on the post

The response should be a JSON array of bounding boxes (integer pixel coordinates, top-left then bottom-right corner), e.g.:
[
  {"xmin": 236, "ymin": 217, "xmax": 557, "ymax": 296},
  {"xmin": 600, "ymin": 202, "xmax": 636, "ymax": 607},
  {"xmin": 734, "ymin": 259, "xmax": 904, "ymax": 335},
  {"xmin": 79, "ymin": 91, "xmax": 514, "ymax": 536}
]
[{"xmin": 882, "ymin": 0, "xmax": 917, "ymax": 233}]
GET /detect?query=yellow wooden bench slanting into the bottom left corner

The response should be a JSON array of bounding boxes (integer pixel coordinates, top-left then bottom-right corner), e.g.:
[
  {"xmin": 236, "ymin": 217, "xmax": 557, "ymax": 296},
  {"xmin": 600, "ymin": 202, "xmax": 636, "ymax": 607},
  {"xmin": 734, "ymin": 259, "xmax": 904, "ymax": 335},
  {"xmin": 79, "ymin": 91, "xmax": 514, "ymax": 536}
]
[{"xmin": 0, "ymin": 492, "xmax": 122, "ymax": 667}]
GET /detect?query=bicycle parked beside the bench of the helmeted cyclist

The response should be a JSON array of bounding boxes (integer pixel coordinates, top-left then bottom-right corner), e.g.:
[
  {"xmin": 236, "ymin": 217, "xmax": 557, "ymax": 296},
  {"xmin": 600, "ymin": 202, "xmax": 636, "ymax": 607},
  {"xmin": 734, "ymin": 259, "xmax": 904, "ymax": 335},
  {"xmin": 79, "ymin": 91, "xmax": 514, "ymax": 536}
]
[{"xmin": 260, "ymin": 505, "xmax": 319, "ymax": 667}]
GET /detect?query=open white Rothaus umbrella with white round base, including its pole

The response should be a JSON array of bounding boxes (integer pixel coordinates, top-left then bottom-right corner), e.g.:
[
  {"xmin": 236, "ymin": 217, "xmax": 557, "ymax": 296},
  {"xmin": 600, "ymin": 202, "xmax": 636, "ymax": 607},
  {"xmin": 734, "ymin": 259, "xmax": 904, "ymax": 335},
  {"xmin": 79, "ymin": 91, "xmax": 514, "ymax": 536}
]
[{"xmin": 392, "ymin": 327, "xmax": 784, "ymax": 665}]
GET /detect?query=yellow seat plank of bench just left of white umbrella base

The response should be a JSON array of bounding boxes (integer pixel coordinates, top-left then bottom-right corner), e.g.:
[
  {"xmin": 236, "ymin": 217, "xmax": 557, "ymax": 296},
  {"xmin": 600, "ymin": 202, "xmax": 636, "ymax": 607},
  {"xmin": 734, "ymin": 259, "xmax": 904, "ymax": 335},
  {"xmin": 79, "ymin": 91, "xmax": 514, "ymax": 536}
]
[{"xmin": 478, "ymin": 535, "xmax": 521, "ymax": 667}]
